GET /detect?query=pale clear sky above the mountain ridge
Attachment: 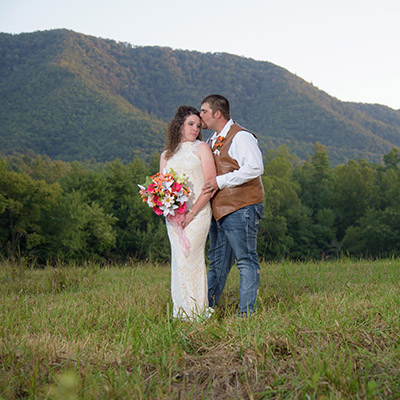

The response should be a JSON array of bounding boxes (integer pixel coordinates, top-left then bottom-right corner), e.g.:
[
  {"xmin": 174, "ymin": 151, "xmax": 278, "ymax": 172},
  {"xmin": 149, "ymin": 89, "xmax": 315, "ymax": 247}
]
[{"xmin": 0, "ymin": 0, "xmax": 400, "ymax": 110}]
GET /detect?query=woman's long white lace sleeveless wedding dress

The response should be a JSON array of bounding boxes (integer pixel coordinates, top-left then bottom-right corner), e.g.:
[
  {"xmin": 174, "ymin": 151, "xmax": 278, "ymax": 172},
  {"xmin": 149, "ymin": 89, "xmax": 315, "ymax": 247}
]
[{"xmin": 166, "ymin": 140, "xmax": 212, "ymax": 320}]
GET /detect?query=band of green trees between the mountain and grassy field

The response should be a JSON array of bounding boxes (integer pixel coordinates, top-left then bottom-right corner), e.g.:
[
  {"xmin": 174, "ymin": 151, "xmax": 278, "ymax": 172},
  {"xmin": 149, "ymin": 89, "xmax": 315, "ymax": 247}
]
[{"xmin": 0, "ymin": 143, "xmax": 400, "ymax": 264}]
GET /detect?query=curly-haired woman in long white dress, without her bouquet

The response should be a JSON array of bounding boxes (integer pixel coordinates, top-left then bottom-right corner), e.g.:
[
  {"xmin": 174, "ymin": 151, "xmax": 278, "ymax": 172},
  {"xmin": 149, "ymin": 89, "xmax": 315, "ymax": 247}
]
[{"xmin": 160, "ymin": 106, "xmax": 216, "ymax": 320}]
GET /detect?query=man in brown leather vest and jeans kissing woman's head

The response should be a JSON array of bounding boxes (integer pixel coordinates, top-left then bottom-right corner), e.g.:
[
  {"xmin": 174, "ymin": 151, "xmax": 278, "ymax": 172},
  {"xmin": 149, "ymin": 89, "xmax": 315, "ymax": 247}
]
[{"xmin": 200, "ymin": 94, "xmax": 264, "ymax": 316}]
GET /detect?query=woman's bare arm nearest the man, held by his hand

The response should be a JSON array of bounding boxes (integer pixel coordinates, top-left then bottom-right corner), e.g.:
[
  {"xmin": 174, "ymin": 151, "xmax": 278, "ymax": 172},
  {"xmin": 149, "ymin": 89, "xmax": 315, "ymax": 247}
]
[{"xmin": 183, "ymin": 143, "xmax": 217, "ymax": 228}]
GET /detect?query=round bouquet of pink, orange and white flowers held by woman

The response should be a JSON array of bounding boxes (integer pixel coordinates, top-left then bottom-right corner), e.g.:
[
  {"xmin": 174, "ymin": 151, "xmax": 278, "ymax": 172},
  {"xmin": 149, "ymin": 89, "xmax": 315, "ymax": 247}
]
[{"xmin": 138, "ymin": 169, "xmax": 190, "ymax": 217}]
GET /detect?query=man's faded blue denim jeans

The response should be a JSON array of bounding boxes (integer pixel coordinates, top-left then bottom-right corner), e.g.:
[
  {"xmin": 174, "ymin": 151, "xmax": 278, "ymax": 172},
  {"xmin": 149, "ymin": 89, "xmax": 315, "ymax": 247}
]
[{"xmin": 207, "ymin": 203, "xmax": 264, "ymax": 314}]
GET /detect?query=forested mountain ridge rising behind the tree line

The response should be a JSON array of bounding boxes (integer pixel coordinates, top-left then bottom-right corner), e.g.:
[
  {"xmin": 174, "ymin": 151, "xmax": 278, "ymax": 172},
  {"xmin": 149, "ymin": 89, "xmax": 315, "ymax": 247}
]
[{"xmin": 0, "ymin": 29, "xmax": 400, "ymax": 164}]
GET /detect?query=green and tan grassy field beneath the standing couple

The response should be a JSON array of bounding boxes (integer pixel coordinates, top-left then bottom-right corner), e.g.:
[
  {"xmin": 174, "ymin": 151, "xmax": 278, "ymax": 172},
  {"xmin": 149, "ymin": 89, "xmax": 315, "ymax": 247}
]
[{"xmin": 0, "ymin": 260, "xmax": 400, "ymax": 400}]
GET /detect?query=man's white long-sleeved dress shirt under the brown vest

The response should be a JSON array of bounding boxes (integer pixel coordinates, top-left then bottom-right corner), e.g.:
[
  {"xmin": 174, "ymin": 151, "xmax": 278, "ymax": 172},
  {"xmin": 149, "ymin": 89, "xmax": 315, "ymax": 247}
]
[{"xmin": 209, "ymin": 119, "xmax": 264, "ymax": 189}]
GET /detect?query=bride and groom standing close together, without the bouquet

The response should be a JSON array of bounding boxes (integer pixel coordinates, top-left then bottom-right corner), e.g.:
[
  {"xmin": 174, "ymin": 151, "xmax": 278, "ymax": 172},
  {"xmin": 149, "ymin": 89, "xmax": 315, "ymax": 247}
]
[{"xmin": 160, "ymin": 94, "xmax": 264, "ymax": 320}]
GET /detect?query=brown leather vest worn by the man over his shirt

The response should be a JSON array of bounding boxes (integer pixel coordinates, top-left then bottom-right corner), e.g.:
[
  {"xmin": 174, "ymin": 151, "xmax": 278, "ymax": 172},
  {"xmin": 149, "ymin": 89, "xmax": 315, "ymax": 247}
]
[{"xmin": 211, "ymin": 124, "xmax": 264, "ymax": 221}]
